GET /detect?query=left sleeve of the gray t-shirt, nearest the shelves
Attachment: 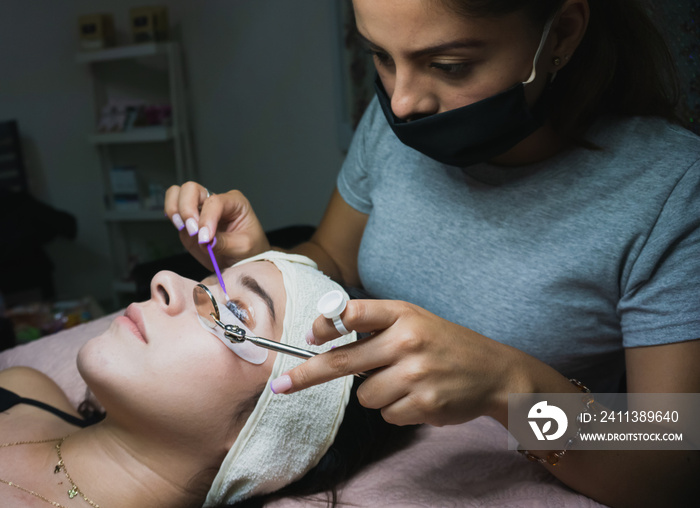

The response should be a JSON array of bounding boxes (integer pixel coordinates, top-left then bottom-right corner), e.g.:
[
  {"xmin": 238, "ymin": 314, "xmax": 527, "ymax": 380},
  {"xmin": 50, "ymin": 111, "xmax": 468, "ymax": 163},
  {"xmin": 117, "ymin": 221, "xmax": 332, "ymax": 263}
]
[{"xmin": 337, "ymin": 97, "xmax": 381, "ymax": 214}]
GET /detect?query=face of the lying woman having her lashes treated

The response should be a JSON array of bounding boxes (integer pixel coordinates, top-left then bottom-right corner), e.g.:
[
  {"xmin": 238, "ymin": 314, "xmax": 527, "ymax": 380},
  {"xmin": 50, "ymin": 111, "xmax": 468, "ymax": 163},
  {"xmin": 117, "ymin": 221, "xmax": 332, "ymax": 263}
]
[{"xmin": 78, "ymin": 261, "xmax": 286, "ymax": 438}]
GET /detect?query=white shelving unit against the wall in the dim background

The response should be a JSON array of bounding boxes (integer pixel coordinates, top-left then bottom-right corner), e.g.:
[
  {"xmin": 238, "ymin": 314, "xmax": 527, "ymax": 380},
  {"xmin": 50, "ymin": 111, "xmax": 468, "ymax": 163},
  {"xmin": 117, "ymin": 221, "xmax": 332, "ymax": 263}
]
[{"xmin": 75, "ymin": 42, "xmax": 195, "ymax": 304}]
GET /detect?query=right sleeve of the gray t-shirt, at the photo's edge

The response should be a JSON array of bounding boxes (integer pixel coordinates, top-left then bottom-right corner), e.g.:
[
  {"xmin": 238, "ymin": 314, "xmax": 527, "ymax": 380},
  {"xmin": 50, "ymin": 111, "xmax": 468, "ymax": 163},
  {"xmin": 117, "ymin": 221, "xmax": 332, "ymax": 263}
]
[{"xmin": 618, "ymin": 161, "xmax": 700, "ymax": 347}]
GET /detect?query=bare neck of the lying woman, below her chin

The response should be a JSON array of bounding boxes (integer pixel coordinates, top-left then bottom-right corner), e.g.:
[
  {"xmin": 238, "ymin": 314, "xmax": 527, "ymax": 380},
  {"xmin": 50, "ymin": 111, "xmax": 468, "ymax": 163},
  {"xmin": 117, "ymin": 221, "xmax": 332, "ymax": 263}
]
[{"xmin": 61, "ymin": 418, "xmax": 223, "ymax": 508}]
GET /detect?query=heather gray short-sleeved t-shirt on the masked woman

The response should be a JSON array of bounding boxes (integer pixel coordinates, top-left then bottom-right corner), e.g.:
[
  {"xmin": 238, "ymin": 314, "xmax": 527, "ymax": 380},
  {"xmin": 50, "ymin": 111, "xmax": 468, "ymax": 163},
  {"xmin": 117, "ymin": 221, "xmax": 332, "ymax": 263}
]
[{"xmin": 338, "ymin": 98, "xmax": 700, "ymax": 391}]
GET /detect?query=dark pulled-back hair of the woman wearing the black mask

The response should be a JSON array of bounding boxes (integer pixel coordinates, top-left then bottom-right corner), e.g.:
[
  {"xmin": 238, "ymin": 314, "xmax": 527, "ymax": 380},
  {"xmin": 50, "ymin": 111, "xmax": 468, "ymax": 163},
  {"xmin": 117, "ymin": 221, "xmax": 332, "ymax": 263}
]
[{"xmin": 439, "ymin": 0, "xmax": 680, "ymax": 144}]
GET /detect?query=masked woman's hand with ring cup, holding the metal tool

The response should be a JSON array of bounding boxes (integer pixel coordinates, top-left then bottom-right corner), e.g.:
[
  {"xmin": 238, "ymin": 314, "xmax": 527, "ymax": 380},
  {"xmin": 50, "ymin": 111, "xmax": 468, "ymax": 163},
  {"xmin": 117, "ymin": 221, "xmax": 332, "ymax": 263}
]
[{"xmin": 273, "ymin": 300, "xmax": 524, "ymax": 426}]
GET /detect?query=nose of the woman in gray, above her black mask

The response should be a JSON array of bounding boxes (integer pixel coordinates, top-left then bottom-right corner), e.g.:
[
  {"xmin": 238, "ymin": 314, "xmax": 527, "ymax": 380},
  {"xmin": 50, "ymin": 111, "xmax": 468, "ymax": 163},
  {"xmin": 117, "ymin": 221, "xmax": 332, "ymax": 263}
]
[{"xmin": 385, "ymin": 71, "xmax": 439, "ymax": 121}]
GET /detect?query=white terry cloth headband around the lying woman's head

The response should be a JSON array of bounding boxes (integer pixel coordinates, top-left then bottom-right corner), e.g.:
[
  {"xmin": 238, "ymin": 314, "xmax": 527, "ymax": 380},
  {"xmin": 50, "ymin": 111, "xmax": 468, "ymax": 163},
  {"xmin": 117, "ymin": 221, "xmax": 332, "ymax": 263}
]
[{"xmin": 204, "ymin": 251, "xmax": 357, "ymax": 507}]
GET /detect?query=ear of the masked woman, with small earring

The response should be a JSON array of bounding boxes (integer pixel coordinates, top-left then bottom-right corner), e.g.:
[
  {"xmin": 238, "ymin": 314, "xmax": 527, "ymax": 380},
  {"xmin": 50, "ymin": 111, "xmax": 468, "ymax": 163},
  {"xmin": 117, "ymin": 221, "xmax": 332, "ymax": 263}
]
[{"xmin": 549, "ymin": 0, "xmax": 590, "ymax": 72}]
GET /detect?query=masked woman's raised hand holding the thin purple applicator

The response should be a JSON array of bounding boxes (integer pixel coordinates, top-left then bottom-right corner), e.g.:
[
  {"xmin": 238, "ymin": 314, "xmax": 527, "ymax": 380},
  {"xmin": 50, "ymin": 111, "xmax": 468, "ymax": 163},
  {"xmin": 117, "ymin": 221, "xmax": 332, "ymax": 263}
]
[{"xmin": 165, "ymin": 182, "xmax": 270, "ymax": 270}]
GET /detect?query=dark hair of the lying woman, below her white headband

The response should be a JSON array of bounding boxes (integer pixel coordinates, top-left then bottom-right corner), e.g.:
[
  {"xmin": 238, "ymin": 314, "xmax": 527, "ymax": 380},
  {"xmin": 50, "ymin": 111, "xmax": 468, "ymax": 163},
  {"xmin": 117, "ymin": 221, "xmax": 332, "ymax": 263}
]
[{"xmin": 223, "ymin": 378, "xmax": 416, "ymax": 508}]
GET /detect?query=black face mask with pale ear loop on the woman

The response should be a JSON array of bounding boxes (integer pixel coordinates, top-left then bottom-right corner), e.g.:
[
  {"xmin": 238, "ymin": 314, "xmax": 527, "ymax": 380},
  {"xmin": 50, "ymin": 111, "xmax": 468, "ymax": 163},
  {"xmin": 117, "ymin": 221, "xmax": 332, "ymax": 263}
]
[{"xmin": 374, "ymin": 13, "xmax": 553, "ymax": 167}]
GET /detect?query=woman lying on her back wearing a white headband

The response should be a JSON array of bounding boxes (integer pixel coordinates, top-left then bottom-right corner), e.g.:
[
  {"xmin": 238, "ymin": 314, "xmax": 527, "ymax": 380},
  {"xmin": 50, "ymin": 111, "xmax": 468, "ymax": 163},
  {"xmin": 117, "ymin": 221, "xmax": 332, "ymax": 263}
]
[{"xmin": 0, "ymin": 252, "xmax": 400, "ymax": 508}]
